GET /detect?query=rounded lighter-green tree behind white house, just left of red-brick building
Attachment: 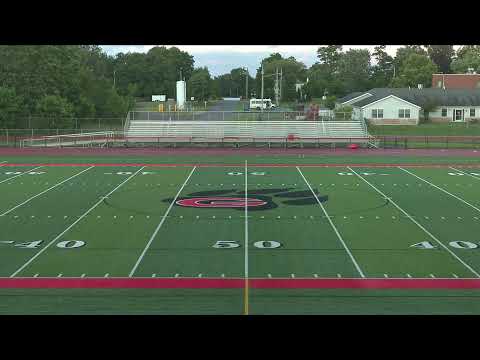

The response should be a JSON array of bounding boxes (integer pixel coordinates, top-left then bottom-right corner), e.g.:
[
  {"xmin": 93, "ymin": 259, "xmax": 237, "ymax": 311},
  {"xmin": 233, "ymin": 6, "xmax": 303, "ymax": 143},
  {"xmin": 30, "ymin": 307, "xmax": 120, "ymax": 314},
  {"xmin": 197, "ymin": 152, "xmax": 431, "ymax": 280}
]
[{"xmin": 391, "ymin": 53, "xmax": 438, "ymax": 87}]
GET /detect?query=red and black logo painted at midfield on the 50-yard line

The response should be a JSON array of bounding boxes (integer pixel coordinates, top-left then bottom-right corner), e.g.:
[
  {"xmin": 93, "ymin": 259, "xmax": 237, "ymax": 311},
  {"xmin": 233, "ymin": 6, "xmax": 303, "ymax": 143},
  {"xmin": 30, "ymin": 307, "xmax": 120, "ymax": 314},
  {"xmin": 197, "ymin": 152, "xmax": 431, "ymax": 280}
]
[{"xmin": 163, "ymin": 188, "xmax": 328, "ymax": 211}]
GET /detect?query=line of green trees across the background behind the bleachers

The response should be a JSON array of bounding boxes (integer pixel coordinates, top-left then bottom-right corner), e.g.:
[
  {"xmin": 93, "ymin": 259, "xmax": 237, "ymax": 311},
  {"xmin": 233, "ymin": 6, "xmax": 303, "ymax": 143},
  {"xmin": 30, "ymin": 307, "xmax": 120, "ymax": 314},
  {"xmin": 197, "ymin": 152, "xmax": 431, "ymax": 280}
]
[{"xmin": 0, "ymin": 45, "xmax": 480, "ymax": 128}]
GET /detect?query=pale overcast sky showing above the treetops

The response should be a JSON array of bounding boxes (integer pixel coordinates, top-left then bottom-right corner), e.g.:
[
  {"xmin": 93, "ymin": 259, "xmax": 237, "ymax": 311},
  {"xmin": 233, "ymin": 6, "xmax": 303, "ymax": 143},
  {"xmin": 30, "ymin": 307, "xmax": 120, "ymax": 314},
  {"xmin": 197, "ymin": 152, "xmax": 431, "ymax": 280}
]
[{"xmin": 101, "ymin": 45, "xmax": 401, "ymax": 76}]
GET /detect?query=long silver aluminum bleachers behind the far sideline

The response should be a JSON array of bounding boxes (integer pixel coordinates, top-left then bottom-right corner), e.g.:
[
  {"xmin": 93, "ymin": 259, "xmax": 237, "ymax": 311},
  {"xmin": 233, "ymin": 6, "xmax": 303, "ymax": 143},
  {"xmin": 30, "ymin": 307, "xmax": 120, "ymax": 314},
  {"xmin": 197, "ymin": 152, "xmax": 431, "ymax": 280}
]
[{"xmin": 125, "ymin": 120, "xmax": 371, "ymax": 144}]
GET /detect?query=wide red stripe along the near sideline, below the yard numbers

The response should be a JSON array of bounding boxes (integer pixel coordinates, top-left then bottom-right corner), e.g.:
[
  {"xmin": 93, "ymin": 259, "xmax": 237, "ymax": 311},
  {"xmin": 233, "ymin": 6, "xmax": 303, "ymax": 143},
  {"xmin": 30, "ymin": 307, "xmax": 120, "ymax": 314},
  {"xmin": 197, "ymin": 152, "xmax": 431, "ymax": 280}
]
[{"xmin": 0, "ymin": 278, "xmax": 480, "ymax": 290}]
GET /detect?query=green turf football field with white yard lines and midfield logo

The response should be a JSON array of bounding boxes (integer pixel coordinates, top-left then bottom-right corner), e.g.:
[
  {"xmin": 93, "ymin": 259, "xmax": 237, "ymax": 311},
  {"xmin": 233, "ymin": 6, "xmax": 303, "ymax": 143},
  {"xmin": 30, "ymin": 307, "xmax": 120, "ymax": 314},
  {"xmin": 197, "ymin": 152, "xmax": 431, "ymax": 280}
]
[{"xmin": 0, "ymin": 157, "xmax": 480, "ymax": 314}]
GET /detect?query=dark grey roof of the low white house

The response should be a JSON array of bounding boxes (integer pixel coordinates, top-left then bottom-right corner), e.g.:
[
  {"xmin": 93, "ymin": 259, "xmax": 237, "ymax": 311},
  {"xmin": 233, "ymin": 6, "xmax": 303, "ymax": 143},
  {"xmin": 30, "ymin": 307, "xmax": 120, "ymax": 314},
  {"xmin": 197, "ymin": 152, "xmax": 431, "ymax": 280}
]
[{"xmin": 346, "ymin": 88, "xmax": 480, "ymax": 107}]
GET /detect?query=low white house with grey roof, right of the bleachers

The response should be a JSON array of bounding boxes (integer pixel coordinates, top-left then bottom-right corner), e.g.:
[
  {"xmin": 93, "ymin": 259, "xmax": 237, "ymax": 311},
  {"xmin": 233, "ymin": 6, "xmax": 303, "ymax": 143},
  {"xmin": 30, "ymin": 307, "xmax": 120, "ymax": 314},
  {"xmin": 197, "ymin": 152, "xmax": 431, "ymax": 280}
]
[{"xmin": 335, "ymin": 88, "xmax": 480, "ymax": 125}]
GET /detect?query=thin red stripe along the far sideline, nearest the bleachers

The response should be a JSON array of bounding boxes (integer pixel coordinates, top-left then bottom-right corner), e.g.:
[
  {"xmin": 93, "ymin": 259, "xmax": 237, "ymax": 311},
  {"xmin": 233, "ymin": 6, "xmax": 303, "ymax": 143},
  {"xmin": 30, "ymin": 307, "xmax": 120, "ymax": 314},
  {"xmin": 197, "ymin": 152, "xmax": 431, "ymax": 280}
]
[{"xmin": 1, "ymin": 163, "xmax": 480, "ymax": 168}]
